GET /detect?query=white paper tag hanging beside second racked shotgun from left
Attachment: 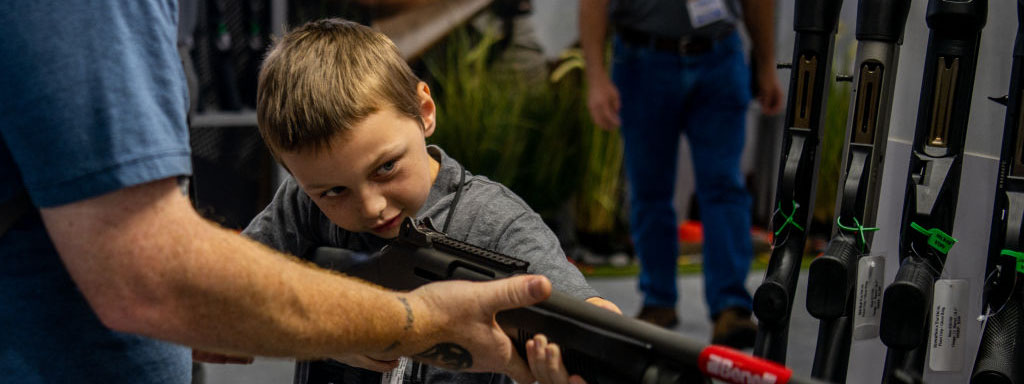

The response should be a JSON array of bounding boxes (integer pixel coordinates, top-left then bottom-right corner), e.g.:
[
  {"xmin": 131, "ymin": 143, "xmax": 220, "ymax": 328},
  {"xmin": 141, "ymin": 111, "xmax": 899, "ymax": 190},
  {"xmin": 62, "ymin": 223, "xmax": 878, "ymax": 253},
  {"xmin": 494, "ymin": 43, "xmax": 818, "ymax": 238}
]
[{"xmin": 853, "ymin": 255, "xmax": 886, "ymax": 340}]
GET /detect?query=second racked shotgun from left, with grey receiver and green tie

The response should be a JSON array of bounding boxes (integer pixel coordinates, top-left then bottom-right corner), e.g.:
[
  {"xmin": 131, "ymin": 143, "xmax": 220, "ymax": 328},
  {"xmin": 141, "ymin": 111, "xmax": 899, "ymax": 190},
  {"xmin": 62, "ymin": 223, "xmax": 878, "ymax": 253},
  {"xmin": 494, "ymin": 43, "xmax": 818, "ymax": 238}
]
[{"xmin": 807, "ymin": 0, "xmax": 910, "ymax": 383}]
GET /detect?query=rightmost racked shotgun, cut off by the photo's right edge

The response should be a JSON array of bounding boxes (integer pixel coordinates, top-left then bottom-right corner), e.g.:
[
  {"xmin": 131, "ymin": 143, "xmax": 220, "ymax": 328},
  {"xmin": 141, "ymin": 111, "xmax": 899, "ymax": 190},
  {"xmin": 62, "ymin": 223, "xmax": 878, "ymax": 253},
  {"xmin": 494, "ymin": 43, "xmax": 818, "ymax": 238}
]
[{"xmin": 971, "ymin": 0, "xmax": 1024, "ymax": 384}]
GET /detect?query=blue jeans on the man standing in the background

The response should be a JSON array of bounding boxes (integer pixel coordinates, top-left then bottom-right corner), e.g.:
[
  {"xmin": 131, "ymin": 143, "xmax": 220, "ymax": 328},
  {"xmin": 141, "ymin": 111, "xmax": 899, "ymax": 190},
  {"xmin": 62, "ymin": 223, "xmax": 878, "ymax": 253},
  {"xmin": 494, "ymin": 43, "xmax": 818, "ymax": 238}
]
[{"xmin": 612, "ymin": 33, "xmax": 753, "ymax": 316}]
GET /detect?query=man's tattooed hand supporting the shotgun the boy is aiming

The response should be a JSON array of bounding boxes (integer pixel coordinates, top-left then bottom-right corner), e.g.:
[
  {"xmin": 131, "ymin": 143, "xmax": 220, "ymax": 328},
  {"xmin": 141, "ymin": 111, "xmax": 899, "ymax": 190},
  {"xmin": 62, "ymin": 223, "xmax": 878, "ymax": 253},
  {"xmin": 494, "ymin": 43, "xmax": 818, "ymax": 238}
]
[{"xmin": 397, "ymin": 275, "xmax": 551, "ymax": 383}]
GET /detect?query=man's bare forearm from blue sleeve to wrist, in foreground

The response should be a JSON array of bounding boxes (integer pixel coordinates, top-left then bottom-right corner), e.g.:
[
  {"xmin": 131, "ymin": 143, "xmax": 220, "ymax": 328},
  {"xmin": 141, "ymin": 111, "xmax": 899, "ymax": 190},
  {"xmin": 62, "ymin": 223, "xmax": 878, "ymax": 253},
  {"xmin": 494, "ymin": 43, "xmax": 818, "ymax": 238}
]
[{"xmin": 42, "ymin": 180, "xmax": 430, "ymax": 357}]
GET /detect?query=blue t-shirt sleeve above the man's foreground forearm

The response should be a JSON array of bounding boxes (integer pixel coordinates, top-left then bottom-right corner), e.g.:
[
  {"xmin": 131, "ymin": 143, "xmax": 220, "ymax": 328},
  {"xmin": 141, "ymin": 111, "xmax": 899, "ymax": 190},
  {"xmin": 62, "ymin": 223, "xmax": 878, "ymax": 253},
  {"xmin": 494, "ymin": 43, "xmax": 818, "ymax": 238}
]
[{"xmin": 0, "ymin": 0, "xmax": 191, "ymax": 207}]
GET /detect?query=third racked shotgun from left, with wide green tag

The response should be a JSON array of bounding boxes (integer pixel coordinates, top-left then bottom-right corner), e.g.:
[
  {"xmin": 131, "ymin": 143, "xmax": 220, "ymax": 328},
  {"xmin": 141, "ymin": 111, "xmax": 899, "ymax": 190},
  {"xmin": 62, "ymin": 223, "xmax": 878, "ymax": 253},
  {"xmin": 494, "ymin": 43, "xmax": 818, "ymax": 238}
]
[{"xmin": 879, "ymin": 0, "xmax": 988, "ymax": 380}]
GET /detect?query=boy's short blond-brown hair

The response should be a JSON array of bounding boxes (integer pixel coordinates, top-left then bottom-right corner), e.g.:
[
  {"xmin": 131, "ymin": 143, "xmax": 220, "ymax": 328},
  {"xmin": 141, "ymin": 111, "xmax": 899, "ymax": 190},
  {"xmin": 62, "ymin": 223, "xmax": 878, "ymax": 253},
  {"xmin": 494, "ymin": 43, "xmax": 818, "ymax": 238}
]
[{"xmin": 256, "ymin": 18, "xmax": 422, "ymax": 156}]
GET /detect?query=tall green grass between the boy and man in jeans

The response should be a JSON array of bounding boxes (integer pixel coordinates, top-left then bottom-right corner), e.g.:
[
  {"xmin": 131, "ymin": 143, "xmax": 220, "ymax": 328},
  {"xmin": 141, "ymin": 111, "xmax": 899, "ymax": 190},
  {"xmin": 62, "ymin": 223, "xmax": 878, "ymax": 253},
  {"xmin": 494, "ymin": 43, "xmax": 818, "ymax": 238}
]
[{"xmin": 424, "ymin": 29, "xmax": 622, "ymax": 232}]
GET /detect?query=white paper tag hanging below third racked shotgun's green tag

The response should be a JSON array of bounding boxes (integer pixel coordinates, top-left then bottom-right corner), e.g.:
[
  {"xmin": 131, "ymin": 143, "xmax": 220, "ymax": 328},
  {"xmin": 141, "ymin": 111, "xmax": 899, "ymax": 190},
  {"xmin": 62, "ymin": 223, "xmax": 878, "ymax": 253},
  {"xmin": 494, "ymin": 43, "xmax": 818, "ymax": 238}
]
[{"xmin": 928, "ymin": 280, "xmax": 970, "ymax": 372}]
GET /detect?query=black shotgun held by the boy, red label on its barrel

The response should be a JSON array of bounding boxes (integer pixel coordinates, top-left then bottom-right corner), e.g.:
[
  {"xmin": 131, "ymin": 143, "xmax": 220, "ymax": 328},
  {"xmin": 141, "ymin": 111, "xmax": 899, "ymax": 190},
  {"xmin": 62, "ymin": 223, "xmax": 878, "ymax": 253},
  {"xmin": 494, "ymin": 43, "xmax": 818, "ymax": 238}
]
[{"xmin": 297, "ymin": 219, "xmax": 816, "ymax": 384}]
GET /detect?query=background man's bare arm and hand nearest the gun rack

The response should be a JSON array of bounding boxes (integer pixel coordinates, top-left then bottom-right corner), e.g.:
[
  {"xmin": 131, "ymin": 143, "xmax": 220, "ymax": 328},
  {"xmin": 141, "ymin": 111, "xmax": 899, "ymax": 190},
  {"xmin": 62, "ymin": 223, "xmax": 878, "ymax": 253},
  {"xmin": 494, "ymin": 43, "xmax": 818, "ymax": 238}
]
[{"xmin": 742, "ymin": 0, "xmax": 782, "ymax": 115}]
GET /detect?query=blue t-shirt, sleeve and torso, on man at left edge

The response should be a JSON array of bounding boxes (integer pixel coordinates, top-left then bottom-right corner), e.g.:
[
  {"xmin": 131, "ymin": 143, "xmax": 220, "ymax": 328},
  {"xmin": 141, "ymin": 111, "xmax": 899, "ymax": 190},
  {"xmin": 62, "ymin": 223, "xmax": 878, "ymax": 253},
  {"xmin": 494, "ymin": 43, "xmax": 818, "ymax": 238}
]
[{"xmin": 0, "ymin": 0, "xmax": 191, "ymax": 383}]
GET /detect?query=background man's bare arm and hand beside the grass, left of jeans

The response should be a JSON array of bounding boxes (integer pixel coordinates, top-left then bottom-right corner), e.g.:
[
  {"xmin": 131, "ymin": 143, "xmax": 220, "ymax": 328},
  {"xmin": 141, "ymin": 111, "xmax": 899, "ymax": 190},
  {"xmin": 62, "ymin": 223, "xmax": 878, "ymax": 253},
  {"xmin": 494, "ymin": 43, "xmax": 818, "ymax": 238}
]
[{"xmin": 580, "ymin": 0, "xmax": 621, "ymax": 129}]
